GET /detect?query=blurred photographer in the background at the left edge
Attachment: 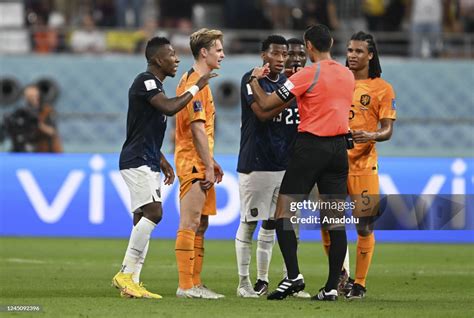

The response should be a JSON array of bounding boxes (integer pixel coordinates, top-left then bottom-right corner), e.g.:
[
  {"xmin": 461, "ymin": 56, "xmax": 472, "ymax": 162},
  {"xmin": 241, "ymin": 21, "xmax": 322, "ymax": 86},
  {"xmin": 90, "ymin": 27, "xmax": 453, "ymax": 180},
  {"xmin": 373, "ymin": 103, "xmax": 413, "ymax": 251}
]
[{"xmin": 4, "ymin": 85, "xmax": 63, "ymax": 152}]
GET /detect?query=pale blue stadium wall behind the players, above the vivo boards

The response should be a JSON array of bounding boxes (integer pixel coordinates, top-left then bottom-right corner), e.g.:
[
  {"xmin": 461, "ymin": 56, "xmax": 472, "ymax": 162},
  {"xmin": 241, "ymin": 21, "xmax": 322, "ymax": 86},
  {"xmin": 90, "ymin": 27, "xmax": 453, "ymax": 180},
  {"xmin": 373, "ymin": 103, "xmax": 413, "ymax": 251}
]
[{"xmin": 0, "ymin": 55, "xmax": 474, "ymax": 156}]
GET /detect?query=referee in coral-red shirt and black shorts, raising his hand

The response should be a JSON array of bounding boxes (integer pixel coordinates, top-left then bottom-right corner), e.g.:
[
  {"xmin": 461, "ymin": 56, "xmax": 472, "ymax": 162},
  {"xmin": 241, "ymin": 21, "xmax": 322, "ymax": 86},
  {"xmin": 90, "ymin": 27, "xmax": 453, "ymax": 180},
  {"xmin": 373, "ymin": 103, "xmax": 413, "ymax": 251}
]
[{"xmin": 248, "ymin": 24, "xmax": 355, "ymax": 300}]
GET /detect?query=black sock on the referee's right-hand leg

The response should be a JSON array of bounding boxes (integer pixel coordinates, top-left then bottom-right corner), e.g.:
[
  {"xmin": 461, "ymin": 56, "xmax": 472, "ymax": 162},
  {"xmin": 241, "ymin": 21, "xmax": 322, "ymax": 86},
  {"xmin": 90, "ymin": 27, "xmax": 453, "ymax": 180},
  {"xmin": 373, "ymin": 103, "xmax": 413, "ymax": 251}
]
[{"xmin": 324, "ymin": 229, "xmax": 347, "ymax": 291}]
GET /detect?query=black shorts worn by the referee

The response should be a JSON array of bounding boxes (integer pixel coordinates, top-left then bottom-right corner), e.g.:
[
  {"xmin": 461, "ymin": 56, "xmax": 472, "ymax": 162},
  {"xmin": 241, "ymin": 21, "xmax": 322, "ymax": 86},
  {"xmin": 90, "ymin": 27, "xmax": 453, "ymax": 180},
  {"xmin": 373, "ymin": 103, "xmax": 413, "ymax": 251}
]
[{"xmin": 280, "ymin": 133, "xmax": 349, "ymax": 195}]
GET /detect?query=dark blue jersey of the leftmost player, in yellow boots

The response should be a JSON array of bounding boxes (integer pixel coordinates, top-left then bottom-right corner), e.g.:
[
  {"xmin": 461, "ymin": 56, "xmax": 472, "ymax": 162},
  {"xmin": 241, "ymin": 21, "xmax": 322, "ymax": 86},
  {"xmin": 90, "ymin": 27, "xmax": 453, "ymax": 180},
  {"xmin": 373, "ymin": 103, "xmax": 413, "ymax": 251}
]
[{"xmin": 120, "ymin": 72, "xmax": 166, "ymax": 171}]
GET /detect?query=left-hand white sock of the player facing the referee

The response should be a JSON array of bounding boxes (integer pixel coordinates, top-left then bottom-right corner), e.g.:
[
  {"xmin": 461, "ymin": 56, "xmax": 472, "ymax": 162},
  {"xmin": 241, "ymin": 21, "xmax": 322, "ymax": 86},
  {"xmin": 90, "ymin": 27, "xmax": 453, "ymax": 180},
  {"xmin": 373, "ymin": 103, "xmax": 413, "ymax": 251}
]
[{"xmin": 235, "ymin": 222, "xmax": 257, "ymax": 286}]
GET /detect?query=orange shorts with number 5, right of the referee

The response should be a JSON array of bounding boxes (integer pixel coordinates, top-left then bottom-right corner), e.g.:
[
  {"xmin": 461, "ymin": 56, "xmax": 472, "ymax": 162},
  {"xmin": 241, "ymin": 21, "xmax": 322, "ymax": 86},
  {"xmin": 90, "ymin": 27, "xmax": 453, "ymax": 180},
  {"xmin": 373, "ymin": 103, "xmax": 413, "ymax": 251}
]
[{"xmin": 347, "ymin": 174, "xmax": 380, "ymax": 217}]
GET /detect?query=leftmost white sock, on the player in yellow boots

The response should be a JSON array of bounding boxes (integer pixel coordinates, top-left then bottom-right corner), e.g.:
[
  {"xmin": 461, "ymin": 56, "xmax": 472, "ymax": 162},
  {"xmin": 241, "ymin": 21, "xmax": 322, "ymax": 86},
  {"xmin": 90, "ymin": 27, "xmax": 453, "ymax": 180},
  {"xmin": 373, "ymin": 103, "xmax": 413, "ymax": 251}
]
[{"xmin": 122, "ymin": 217, "xmax": 156, "ymax": 273}]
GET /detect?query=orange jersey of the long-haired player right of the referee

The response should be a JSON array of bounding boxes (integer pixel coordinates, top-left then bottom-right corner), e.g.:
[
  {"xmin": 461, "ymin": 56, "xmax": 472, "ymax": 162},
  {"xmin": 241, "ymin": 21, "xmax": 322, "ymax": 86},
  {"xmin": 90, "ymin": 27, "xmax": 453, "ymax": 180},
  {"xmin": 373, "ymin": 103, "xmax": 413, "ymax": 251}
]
[{"xmin": 348, "ymin": 78, "xmax": 397, "ymax": 175}]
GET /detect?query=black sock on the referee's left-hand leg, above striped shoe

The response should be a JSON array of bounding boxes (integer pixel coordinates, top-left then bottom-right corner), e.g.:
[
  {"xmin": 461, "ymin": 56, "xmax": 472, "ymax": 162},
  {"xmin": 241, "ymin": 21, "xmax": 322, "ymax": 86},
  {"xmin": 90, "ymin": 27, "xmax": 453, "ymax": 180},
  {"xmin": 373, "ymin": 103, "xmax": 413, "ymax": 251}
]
[{"xmin": 276, "ymin": 218, "xmax": 298, "ymax": 279}]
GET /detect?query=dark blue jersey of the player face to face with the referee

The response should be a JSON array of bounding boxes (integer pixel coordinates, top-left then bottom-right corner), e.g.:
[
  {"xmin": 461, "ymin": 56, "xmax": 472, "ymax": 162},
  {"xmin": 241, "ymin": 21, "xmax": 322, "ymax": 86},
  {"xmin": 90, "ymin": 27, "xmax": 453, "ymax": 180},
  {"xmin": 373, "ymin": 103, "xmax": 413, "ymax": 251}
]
[{"xmin": 237, "ymin": 72, "xmax": 299, "ymax": 173}]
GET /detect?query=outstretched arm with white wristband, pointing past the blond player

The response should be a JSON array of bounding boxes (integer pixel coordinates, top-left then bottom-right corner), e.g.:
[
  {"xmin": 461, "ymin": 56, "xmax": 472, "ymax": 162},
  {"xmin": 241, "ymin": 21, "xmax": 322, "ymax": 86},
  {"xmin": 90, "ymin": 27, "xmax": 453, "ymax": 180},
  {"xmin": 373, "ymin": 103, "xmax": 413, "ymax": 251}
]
[{"xmin": 150, "ymin": 73, "xmax": 217, "ymax": 116}]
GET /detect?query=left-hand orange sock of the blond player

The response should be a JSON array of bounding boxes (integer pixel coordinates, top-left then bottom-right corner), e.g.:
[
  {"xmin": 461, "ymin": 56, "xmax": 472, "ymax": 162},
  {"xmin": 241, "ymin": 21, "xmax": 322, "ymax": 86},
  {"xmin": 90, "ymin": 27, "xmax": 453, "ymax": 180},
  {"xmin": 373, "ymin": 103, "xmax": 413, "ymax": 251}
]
[{"xmin": 174, "ymin": 230, "xmax": 196, "ymax": 289}]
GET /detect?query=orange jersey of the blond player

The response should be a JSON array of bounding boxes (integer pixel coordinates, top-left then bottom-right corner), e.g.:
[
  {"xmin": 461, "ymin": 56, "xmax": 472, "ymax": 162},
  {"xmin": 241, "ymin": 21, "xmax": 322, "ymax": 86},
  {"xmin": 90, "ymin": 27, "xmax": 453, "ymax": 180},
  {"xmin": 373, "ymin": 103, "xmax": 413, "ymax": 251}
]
[{"xmin": 174, "ymin": 69, "xmax": 215, "ymax": 177}]
